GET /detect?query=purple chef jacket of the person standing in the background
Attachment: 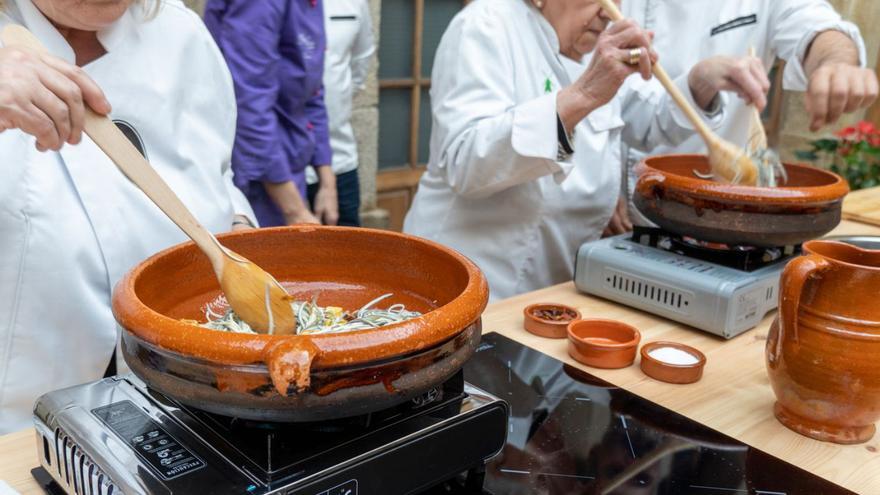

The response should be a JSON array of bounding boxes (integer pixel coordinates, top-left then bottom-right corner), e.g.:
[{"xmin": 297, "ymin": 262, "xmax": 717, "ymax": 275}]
[{"xmin": 205, "ymin": 0, "xmax": 331, "ymax": 226}]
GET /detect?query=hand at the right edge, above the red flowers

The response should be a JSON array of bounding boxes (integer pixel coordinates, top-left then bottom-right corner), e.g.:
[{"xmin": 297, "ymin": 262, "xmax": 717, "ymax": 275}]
[{"xmin": 804, "ymin": 63, "xmax": 878, "ymax": 132}]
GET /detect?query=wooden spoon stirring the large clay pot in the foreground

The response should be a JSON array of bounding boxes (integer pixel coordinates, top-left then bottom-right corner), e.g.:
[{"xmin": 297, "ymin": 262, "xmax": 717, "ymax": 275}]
[{"xmin": 0, "ymin": 25, "xmax": 296, "ymax": 334}]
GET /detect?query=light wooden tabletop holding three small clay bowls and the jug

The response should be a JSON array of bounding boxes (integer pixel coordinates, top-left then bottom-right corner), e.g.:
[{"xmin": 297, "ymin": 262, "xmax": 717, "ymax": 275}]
[{"xmin": 0, "ymin": 221, "xmax": 880, "ymax": 495}]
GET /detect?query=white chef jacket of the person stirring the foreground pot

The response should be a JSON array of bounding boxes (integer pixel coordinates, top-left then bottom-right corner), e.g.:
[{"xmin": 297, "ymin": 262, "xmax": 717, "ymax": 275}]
[{"xmin": 0, "ymin": 0, "xmax": 253, "ymax": 433}]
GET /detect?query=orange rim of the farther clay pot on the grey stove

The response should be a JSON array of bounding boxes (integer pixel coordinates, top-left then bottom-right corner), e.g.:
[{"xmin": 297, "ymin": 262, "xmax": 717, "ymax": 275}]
[{"xmin": 636, "ymin": 154, "xmax": 849, "ymax": 205}]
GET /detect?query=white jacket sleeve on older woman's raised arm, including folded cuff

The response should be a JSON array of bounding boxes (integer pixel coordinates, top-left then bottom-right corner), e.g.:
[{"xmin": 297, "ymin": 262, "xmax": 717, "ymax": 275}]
[{"xmin": 429, "ymin": 16, "xmax": 572, "ymax": 198}]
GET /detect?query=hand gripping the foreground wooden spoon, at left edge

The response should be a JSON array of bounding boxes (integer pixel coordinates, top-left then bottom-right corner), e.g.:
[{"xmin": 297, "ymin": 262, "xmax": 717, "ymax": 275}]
[{"xmin": 0, "ymin": 47, "xmax": 110, "ymax": 151}]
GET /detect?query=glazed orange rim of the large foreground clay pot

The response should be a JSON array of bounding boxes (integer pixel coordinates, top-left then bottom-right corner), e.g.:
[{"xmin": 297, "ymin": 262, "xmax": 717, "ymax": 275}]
[{"xmin": 112, "ymin": 225, "xmax": 489, "ymax": 369}]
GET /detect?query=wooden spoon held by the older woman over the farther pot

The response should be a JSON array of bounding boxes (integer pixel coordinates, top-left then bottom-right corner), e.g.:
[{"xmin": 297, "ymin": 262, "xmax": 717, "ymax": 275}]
[{"xmin": 599, "ymin": 0, "xmax": 758, "ymax": 186}]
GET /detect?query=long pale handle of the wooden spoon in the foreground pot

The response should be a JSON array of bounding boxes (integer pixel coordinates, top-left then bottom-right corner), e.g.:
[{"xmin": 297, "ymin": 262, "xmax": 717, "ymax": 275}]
[{"xmin": 0, "ymin": 24, "xmax": 224, "ymax": 273}]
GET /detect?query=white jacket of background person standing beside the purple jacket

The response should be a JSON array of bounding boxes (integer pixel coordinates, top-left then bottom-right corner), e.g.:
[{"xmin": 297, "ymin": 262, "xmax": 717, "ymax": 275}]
[{"xmin": 306, "ymin": 0, "xmax": 376, "ymax": 184}]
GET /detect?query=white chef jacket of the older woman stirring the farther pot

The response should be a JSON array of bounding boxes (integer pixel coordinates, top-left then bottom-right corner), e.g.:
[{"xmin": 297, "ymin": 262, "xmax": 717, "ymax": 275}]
[{"xmin": 404, "ymin": 0, "xmax": 724, "ymax": 300}]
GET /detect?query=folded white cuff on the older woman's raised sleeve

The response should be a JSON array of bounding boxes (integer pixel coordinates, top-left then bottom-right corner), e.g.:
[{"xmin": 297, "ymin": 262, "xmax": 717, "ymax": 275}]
[{"xmin": 510, "ymin": 91, "xmax": 577, "ymax": 183}]
